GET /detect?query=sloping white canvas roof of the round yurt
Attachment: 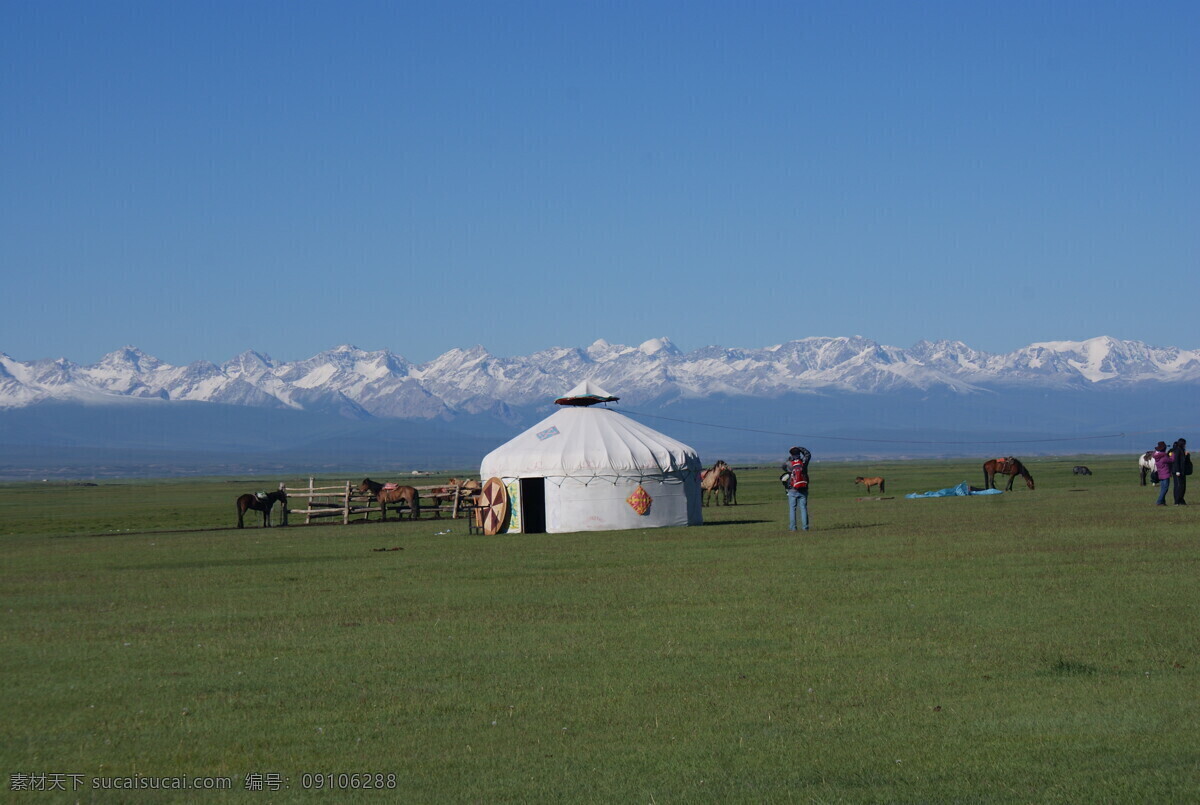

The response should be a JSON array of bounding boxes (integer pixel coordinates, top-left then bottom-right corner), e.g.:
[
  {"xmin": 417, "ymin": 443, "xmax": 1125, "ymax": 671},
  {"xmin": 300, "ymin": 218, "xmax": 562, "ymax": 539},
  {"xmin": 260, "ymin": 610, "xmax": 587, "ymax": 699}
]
[{"xmin": 480, "ymin": 400, "xmax": 700, "ymax": 477}]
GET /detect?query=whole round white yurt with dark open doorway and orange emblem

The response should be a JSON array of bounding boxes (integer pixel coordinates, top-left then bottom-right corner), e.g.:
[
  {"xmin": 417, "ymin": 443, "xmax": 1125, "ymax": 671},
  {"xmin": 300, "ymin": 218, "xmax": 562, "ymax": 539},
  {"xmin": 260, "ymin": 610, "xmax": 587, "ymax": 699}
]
[{"xmin": 480, "ymin": 380, "xmax": 703, "ymax": 534}]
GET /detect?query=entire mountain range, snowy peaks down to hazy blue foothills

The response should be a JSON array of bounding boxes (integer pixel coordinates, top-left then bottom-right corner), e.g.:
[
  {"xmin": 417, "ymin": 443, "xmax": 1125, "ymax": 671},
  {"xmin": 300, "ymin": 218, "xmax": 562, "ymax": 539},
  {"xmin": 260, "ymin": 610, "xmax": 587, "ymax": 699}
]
[{"xmin": 0, "ymin": 337, "xmax": 1200, "ymax": 477}]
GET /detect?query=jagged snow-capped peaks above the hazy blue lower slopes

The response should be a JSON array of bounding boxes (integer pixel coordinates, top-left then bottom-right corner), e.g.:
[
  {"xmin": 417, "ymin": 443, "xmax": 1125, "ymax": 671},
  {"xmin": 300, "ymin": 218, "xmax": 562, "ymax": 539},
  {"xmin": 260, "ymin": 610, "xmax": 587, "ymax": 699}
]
[{"xmin": 0, "ymin": 336, "xmax": 1200, "ymax": 420}]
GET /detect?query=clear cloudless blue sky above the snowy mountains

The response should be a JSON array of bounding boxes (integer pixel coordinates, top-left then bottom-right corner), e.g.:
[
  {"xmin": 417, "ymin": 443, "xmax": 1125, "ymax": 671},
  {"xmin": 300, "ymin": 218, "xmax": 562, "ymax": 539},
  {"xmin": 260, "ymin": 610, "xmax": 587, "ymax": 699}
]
[{"xmin": 0, "ymin": 0, "xmax": 1200, "ymax": 364}]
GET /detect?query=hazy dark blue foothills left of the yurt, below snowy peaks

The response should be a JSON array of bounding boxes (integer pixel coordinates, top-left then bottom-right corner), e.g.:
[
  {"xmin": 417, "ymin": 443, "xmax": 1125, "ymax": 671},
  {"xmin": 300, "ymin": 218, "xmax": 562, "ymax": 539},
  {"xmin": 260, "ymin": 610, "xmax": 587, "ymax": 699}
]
[{"xmin": 0, "ymin": 401, "xmax": 500, "ymax": 479}]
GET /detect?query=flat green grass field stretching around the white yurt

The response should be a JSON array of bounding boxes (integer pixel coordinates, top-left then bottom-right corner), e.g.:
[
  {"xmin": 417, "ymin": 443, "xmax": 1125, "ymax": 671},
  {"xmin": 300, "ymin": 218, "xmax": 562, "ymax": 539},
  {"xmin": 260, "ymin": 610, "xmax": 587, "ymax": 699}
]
[{"xmin": 0, "ymin": 457, "xmax": 1200, "ymax": 803}]
